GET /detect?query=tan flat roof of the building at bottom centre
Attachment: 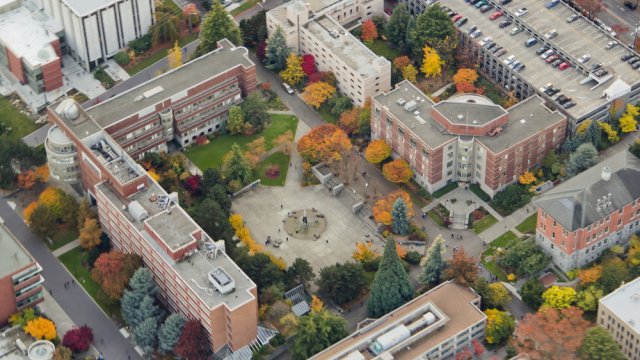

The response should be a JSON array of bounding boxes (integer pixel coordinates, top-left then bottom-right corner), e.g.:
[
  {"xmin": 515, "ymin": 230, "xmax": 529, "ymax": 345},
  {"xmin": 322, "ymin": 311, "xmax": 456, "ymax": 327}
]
[{"xmin": 312, "ymin": 281, "xmax": 486, "ymax": 359}]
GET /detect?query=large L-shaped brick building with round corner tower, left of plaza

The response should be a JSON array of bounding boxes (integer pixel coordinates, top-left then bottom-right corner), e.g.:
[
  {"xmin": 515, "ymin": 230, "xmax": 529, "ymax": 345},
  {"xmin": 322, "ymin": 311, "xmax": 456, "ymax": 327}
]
[{"xmin": 46, "ymin": 40, "xmax": 264, "ymax": 356}]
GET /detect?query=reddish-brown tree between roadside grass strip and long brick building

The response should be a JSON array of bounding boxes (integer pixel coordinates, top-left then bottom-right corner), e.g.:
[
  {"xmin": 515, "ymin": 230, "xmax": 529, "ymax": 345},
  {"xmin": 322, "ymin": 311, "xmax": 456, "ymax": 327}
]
[{"xmin": 91, "ymin": 250, "xmax": 142, "ymax": 300}]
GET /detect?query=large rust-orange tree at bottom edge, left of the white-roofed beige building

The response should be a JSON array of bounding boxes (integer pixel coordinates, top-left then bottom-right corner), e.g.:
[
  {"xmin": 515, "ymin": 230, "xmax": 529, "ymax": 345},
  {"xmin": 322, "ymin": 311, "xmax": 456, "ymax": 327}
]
[{"xmin": 513, "ymin": 307, "xmax": 590, "ymax": 360}]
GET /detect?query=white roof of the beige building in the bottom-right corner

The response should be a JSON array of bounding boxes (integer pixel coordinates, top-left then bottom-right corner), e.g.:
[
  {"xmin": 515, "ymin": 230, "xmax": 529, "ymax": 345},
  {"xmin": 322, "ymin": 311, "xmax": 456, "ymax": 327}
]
[{"xmin": 600, "ymin": 277, "xmax": 640, "ymax": 334}]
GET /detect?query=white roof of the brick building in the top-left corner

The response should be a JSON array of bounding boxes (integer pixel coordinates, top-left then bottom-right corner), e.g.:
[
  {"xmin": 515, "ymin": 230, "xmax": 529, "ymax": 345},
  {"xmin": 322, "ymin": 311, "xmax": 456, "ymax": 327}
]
[{"xmin": 0, "ymin": 6, "xmax": 62, "ymax": 69}]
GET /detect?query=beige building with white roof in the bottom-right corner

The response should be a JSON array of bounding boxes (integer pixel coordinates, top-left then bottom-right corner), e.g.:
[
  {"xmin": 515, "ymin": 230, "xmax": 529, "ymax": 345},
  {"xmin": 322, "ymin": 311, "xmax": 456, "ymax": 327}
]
[{"xmin": 597, "ymin": 277, "xmax": 640, "ymax": 360}]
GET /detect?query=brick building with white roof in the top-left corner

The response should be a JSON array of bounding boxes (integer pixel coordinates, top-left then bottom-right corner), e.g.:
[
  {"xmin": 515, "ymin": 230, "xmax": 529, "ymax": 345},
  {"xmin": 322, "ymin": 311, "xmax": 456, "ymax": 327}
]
[{"xmin": 0, "ymin": 0, "xmax": 64, "ymax": 93}]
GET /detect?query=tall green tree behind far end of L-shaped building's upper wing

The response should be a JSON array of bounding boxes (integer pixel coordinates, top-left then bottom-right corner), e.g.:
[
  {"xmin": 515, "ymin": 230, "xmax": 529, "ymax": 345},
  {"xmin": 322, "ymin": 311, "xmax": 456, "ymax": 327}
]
[{"xmin": 196, "ymin": 1, "xmax": 242, "ymax": 56}]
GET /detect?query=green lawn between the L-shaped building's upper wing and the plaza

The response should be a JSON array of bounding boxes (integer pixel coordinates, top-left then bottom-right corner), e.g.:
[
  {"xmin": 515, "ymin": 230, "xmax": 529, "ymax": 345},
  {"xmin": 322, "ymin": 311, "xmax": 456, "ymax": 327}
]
[{"xmin": 185, "ymin": 114, "xmax": 298, "ymax": 171}]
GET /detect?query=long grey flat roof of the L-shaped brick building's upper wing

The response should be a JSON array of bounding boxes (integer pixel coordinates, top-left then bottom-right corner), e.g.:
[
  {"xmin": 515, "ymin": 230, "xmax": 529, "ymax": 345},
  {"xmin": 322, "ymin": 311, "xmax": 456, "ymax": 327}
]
[{"xmin": 86, "ymin": 39, "xmax": 254, "ymax": 128}]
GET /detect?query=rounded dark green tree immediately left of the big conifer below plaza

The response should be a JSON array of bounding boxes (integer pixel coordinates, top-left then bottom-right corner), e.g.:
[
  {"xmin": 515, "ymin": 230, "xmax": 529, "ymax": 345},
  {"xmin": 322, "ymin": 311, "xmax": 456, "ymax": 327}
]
[{"xmin": 316, "ymin": 262, "xmax": 365, "ymax": 305}]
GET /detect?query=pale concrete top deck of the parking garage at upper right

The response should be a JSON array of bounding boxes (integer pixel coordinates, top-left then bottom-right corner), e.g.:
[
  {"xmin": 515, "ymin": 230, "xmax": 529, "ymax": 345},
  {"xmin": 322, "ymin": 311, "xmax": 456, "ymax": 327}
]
[{"xmin": 443, "ymin": 0, "xmax": 640, "ymax": 119}]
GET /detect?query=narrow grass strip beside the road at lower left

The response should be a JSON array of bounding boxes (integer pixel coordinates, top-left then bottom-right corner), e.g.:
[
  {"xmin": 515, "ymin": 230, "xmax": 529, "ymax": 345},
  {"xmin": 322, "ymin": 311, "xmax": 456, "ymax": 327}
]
[{"xmin": 58, "ymin": 247, "xmax": 122, "ymax": 321}]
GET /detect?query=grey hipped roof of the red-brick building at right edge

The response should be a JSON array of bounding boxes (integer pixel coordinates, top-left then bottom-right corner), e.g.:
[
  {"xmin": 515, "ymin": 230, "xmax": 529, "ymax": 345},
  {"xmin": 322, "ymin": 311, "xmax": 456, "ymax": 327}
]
[{"xmin": 536, "ymin": 151, "xmax": 640, "ymax": 231}]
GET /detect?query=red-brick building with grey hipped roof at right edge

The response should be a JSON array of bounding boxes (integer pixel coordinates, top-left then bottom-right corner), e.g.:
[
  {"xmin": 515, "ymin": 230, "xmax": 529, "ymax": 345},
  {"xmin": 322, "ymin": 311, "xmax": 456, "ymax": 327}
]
[{"xmin": 536, "ymin": 151, "xmax": 640, "ymax": 271}]
